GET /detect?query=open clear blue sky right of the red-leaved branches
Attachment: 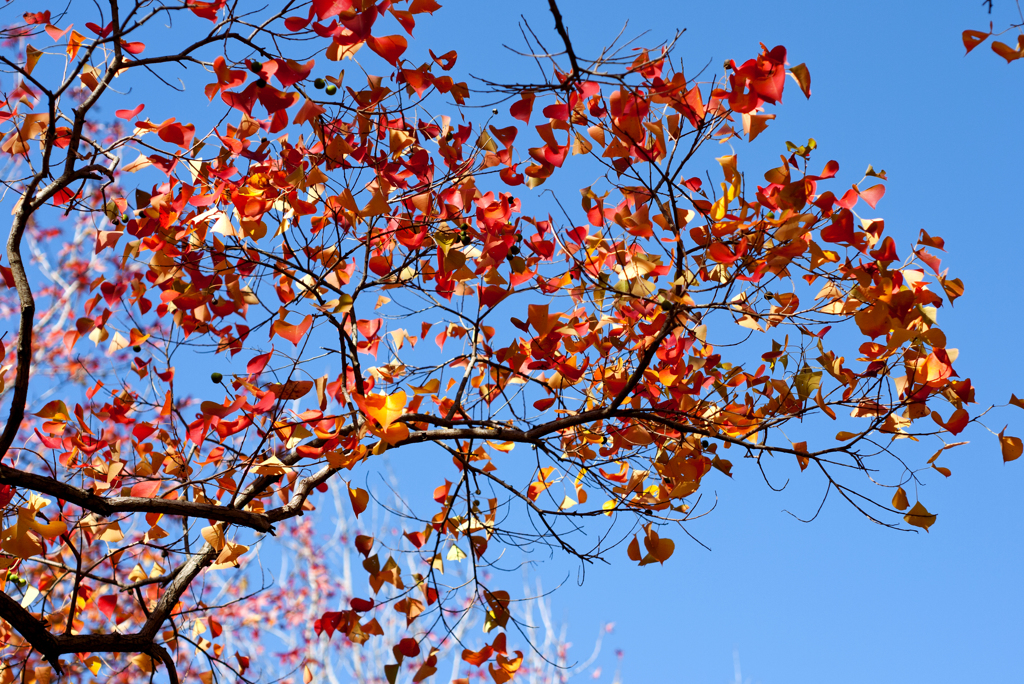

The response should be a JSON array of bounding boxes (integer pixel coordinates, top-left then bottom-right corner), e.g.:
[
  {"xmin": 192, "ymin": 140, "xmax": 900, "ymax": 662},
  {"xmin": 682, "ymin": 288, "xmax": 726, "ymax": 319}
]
[{"xmin": 396, "ymin": 0, "xmax": 1024, "ymax": 684}]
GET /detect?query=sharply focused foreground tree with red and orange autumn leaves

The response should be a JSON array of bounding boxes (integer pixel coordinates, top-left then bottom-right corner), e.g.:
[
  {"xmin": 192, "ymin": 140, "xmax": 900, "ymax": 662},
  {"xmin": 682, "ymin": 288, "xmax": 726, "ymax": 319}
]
[{"xmin": 0, "ymin": 0, "xmax": 1024, "ymax": 683}]
